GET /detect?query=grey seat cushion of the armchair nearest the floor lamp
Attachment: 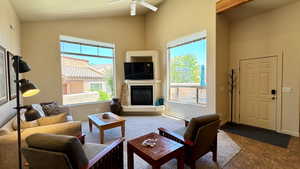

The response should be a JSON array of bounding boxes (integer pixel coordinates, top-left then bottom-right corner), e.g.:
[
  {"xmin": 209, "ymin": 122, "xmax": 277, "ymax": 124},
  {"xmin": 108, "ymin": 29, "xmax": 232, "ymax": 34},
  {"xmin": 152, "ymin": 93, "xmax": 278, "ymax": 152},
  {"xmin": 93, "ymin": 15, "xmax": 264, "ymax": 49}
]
[{"xmin": 82, "ymin": 143, "xmax": 107, "ymax": 160}]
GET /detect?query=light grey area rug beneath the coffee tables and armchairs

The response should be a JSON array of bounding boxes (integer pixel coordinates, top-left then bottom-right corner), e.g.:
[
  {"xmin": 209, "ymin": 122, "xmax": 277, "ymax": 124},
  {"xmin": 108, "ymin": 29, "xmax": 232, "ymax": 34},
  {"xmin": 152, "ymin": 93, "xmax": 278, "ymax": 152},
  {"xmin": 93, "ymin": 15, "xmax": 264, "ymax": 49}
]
[{"xmin": 82, "ymin": 116, "xmax": 240, "ymax": 169}]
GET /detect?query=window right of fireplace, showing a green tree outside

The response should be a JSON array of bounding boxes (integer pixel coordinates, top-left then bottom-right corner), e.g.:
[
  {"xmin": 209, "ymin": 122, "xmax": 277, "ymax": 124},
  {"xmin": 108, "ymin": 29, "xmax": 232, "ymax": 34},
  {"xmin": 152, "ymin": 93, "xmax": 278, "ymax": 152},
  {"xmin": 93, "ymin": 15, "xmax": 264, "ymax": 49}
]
[{"xmin": 168, "ymin": 34, "xmax": 207, "ymax": 105}]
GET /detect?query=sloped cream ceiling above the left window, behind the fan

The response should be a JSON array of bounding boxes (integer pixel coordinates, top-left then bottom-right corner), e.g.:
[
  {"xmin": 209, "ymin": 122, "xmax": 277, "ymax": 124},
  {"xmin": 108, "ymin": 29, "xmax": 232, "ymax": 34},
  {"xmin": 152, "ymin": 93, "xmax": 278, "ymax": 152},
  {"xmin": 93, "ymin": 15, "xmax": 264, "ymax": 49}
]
[{"xmin": 11, "ymin": 0, "xmax": 163, "ymax": 22}]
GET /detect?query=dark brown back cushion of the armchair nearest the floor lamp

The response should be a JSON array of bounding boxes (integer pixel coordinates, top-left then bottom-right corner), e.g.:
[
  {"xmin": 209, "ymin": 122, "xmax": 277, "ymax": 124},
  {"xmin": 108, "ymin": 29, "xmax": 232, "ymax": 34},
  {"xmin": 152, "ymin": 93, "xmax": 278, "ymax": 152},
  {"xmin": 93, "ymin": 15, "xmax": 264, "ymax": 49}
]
[{"xmin": 26, "ymin": 134, "xmax": 89, "ymax": 169}]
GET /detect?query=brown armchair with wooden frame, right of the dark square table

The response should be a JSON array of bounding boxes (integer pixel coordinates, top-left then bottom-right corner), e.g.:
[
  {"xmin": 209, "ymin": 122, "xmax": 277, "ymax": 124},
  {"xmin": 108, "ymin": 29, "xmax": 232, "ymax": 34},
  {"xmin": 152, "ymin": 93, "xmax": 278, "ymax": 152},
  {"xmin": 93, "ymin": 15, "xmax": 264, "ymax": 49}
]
[{"xmin": 158, "ymin": 114, "xmax": 220, "ymax": 169}]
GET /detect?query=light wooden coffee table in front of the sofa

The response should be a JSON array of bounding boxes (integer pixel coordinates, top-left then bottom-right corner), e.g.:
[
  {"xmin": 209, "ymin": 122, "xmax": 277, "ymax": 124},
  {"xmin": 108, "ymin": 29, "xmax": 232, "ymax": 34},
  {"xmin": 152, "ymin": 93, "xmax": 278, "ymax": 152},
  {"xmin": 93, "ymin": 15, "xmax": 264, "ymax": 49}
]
[{"xmin": 88, "ymin": 112, "xmax": 125, "ymax": 144}]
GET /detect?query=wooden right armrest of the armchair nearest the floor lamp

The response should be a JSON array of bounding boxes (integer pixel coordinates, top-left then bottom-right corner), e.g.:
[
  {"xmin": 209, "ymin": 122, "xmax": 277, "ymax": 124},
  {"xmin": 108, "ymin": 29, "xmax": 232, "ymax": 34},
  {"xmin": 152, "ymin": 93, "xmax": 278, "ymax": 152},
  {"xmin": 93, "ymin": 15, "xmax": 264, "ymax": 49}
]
[{"xmin": 88, "ymin": 138, "xmax": 125, "ymax": 168}]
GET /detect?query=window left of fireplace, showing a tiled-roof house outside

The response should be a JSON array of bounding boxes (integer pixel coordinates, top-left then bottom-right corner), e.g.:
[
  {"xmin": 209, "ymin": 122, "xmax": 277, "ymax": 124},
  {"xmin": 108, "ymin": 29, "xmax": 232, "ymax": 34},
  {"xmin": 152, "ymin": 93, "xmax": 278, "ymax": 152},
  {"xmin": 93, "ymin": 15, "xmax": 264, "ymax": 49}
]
[{"xmin": 60, "ymin": 36, "xmax": 114, "ymax": 104}]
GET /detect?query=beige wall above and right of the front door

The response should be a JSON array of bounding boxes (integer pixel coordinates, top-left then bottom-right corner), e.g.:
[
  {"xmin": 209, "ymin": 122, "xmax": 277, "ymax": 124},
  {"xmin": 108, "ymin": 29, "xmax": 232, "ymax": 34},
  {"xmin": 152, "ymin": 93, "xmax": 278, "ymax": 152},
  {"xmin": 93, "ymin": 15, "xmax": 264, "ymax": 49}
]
[{"xmin": 230, "ymin": 2, "xmax": 300, "ymax": 135}]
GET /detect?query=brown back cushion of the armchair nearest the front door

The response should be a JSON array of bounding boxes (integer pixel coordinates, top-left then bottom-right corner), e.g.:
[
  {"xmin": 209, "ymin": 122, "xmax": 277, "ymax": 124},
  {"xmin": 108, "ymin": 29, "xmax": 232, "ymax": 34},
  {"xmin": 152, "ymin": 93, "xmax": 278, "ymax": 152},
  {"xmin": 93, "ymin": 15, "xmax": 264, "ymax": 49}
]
[{"xmin": 184, "ymin": 114, "xmax": 219, "ymax": 141}]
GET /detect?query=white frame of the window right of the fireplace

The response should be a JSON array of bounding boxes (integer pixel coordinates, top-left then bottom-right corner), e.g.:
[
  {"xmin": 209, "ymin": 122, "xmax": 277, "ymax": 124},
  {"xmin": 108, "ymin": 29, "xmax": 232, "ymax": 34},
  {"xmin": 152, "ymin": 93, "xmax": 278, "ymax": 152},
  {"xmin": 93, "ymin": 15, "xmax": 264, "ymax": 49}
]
[{"xmin": 166, "ymin": 31, "xmax": 210, "ymax": 108}]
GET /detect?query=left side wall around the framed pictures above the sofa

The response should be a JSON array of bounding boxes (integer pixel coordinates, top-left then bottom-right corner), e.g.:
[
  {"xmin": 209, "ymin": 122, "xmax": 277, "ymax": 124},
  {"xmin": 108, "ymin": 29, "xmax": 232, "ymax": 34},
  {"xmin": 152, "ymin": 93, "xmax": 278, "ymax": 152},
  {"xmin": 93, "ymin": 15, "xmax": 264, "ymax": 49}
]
[{"xmin": 0, "ymin": 0, "xmax": 21, "ymax": 127}]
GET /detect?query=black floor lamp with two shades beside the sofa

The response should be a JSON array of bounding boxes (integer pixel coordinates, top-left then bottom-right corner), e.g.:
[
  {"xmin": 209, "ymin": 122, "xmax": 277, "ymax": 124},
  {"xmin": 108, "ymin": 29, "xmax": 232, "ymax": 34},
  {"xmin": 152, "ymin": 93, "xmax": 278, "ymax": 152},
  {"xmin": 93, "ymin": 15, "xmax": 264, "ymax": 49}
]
[{"xmin": 13, "ymin": 56, "xmax": 40, "ymax": 169}]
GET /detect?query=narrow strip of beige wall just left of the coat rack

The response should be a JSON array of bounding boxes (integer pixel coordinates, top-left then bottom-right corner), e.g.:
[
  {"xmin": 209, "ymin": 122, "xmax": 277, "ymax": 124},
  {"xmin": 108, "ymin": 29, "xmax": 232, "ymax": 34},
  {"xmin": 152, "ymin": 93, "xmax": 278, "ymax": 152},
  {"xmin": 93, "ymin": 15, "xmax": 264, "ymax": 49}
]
[{"xmin": 216, "ymin": 15, "xmax": 230, "ymax": 122}]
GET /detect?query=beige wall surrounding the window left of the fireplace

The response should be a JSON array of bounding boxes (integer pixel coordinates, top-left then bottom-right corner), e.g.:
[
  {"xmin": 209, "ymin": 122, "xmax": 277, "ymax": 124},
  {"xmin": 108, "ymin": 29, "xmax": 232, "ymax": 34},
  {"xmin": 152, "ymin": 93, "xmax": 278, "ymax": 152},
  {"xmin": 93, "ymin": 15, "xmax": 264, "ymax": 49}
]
[{"xmin": 21, "ymin": 16, "xmax": 145, "ymax": 104}]
